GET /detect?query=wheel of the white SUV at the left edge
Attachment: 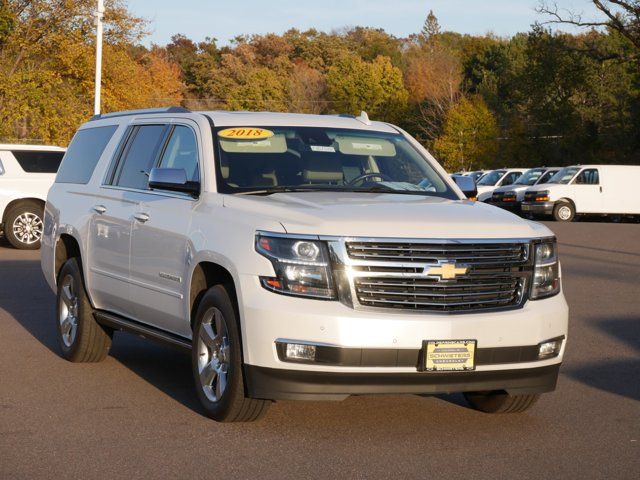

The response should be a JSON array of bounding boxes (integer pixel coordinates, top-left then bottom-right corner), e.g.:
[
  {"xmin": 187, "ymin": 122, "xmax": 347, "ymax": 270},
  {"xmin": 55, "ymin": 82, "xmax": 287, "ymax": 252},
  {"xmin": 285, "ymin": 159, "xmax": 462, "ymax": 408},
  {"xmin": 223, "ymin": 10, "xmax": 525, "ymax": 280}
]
[{"xmin": 4, "ymin": 201, "xmax": 44, "ymax": 250}]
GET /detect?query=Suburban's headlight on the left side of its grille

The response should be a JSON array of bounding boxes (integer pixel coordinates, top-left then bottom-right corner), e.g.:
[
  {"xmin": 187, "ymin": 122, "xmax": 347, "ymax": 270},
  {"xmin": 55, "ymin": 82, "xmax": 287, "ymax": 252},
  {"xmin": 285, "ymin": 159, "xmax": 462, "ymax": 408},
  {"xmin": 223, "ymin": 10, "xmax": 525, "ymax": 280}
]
[{"xmin": 256, "ymin": 234, "xmax": 336, "ymax": 300}]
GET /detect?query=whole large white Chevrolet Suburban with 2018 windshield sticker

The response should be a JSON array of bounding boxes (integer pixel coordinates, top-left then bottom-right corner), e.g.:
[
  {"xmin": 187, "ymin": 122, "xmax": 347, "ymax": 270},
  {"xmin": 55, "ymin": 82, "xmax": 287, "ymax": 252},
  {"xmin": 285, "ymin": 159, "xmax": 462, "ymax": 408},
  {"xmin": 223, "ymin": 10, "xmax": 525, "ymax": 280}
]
[{"xmin": 42, "ymin": 107, "xmax": 568, "ymax": 421}]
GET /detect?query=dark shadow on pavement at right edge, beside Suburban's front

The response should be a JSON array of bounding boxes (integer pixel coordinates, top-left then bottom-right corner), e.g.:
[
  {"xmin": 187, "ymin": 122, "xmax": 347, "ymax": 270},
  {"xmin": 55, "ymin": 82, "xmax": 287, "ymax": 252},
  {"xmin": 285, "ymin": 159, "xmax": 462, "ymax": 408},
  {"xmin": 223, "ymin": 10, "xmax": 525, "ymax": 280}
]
[{"xmin": 564, "ymin": 317, "xmax": 640, "ymax": 401}]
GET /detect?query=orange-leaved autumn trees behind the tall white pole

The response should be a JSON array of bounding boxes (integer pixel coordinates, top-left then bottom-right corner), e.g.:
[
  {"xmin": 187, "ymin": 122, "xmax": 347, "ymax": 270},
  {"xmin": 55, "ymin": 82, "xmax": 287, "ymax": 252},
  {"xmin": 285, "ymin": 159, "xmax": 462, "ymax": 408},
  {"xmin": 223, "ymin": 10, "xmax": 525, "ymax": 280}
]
[{"xmin": 0, "ymin": 0, "xmax": 182, "ymax": 145}]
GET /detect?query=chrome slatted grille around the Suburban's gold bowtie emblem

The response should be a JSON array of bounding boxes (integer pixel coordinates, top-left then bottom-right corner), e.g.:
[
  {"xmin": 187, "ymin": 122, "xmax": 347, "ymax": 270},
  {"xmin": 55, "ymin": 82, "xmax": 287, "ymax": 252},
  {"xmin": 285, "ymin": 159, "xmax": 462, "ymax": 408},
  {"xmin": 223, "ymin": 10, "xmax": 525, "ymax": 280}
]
[{"xmin": 332, "ymin": 241, "xmax": 532, "ymax": 313}]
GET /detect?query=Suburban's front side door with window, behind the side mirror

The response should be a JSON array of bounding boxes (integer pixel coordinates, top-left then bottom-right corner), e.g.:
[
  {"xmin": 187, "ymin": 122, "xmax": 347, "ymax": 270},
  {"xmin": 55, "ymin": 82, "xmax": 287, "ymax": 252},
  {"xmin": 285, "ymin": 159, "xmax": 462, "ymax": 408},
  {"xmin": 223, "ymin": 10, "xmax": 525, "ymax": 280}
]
[{"xmin": 131, "ymin": 120, "xmax": 201, "ymax": 338}]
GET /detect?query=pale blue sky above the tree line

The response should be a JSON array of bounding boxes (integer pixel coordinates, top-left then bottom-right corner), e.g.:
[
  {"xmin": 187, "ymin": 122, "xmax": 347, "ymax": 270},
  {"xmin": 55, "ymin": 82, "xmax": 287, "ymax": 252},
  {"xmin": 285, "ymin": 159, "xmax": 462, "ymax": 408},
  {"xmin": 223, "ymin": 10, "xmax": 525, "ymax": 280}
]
[{"xmin": 128, "ymin": 0, "xmax": 595, "ymax": 45}]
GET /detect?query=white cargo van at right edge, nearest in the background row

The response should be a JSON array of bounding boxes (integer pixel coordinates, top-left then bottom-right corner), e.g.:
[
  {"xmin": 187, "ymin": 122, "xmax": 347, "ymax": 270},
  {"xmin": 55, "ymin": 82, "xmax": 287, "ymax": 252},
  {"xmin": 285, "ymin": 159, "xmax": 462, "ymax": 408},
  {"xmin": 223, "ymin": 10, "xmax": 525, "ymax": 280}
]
[{"xmin": 522, "ymin": 165, "xmax": 640, "ymax": 222}]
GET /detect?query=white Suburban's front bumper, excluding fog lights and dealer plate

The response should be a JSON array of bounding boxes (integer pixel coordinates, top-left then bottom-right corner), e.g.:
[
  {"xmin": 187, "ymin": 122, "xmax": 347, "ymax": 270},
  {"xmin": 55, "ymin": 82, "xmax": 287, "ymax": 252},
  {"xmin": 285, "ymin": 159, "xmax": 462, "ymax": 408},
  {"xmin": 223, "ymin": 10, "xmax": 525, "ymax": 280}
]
[{"xmin": 238, "ymin": 274, "xmax": 569, "ymax": 376}]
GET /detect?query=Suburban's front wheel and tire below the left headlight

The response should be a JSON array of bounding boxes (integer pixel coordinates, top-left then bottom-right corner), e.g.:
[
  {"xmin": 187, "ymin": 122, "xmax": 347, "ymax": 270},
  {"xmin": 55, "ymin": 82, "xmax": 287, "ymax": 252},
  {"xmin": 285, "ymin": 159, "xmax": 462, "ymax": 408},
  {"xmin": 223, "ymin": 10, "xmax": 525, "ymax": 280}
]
[{"xmin": 191, "ymin": 285, "xmax": 270, "ymax": 422}]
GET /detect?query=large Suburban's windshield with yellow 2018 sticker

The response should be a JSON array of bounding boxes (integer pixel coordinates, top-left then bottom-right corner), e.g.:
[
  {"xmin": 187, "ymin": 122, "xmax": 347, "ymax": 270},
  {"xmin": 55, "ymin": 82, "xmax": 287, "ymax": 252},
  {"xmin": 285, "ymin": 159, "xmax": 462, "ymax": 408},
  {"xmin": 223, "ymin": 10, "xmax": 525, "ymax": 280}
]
[{"xmin": 214, "ymin": 126, "xmax": 458, "ymax": 200}]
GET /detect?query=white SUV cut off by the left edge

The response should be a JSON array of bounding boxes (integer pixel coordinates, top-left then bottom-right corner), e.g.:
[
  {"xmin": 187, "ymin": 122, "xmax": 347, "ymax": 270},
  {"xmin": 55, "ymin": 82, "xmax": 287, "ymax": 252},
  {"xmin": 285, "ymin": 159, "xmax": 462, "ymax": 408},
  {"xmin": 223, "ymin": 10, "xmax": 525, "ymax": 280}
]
[{"xmin": 0, "ymin": 144, "xmax": 65, "ymax": 250}]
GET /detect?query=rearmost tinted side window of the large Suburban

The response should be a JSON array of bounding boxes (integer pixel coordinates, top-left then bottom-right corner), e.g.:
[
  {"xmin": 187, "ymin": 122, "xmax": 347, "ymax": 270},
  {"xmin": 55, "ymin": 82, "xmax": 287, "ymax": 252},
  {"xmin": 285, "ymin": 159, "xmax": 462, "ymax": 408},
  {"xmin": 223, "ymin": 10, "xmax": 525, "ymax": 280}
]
[{"xmin": 56, "ymin": 125, "xmax": 118, "ymax": 184}]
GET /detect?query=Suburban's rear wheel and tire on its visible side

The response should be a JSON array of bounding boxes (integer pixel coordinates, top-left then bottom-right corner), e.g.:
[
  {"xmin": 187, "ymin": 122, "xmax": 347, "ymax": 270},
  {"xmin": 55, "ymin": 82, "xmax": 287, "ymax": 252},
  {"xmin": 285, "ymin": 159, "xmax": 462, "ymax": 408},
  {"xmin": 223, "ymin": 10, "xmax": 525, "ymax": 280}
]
[{"xmin": 56, "ymin": 258, "xmax": 112, "ymax": 363}]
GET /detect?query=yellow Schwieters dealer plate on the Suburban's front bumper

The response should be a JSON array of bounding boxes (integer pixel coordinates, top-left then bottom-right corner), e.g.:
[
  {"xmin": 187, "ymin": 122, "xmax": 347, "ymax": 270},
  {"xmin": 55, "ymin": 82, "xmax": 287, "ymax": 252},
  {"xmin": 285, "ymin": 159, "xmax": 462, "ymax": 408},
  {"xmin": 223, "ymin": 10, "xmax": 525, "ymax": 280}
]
[{"xmin": 423, "ymin": 340, "xmax": 476, "ymax": 372}]
